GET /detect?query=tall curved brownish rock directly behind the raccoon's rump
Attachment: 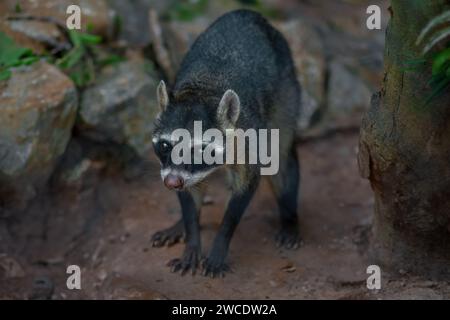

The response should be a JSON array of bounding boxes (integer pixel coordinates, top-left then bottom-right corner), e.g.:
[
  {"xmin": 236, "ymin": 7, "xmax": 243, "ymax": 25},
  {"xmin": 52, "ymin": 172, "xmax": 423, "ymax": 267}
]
[{"xmin": 275, "ymin": 19, "xmax": 327, "ymax": 131}]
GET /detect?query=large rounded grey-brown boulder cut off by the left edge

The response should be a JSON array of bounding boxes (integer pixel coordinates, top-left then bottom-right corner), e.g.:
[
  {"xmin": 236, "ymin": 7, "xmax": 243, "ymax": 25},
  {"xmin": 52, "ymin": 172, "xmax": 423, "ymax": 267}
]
[{"xmin": 0, "ymin": 61, "xmax": 78, "ymax": 208}]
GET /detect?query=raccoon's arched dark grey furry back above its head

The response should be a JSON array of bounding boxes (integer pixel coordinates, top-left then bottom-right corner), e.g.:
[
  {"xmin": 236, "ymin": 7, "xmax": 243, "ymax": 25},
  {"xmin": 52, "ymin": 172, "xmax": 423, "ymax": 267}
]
[{"xmin": 174, "ymin": 10, "xmax": 295, "ymax": 124}]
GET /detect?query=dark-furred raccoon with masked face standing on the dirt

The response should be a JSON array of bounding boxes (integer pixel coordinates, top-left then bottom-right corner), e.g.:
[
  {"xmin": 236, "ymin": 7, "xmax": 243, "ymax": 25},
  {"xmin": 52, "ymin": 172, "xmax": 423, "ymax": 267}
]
[{"xmin": 152, "ymin": 10, "xmax": 301, "ymax": 277}]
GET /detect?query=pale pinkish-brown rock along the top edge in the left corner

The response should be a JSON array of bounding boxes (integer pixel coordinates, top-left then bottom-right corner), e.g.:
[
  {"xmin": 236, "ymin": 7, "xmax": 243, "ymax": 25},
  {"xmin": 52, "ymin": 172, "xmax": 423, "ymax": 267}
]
[{"xmin": 0, "ymin": 0, "xmax": 114, "ymax": 37}]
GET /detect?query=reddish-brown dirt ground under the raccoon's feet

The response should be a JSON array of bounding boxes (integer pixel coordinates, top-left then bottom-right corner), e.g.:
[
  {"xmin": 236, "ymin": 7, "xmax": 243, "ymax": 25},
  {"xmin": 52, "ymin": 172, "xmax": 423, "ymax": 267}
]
[{"xmin": 0, "ymin": 133, "xmax": 450, "ymax": 299}]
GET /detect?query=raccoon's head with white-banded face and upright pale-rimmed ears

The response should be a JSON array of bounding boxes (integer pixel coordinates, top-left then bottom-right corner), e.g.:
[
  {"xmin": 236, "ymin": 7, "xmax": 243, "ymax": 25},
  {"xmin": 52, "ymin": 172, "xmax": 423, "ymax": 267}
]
[{"xmin": 152, "ymin": 81, "xmax": 240, "ymax": 190}]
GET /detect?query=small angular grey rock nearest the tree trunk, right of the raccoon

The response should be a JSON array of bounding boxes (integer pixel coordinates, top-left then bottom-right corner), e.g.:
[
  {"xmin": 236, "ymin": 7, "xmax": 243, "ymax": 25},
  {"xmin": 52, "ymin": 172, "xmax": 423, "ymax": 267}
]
[{"xmin": 325, "ymin": 60, "xmax": 372, "ymax": 128}]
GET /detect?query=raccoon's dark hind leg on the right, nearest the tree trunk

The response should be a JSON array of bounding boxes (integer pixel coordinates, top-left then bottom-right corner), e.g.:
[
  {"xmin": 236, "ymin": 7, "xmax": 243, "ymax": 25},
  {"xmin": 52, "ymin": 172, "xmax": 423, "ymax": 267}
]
[{"xmin": 270, "ymin": 145, "xmax": 301, "ymax": 249}]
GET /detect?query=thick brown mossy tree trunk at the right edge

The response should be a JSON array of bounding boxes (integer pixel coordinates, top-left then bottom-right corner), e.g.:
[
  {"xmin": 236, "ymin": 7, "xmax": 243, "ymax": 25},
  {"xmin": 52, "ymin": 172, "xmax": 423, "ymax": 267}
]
[{"xmin": 358, "ymin": 0, "xmax": 450, "ymax": 278}]
